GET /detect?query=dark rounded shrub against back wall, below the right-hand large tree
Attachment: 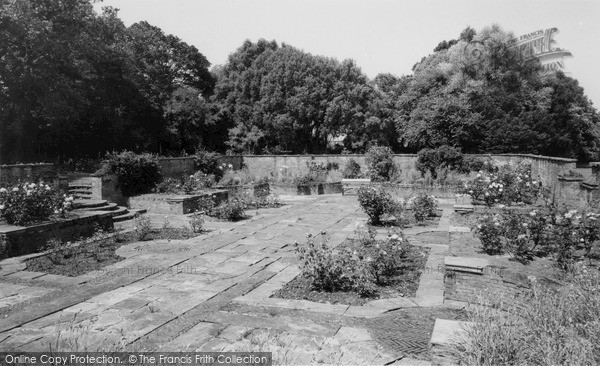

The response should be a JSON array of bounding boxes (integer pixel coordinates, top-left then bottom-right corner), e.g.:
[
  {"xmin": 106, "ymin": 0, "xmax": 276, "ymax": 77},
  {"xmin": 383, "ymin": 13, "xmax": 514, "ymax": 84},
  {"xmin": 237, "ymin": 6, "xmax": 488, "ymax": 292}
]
[{"xmin": 416, "ymin": 145, "xmax": 465, "ymax": 179}]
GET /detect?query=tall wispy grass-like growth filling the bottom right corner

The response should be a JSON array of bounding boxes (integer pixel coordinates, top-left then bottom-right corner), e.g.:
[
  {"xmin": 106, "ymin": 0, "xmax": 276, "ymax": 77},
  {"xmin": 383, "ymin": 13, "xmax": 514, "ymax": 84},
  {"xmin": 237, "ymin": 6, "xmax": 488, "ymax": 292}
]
[{"xmin": 452, "ymin": 264, "xmax": 600, "ymax": 365}]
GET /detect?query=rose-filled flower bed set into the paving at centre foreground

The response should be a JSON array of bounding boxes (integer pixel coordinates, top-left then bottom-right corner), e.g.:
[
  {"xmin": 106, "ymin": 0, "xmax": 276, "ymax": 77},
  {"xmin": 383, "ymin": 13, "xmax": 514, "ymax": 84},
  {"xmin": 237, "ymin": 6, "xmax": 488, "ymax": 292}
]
[{"xmin": 273, "ymin": 229, "xmax": 428, "ymax": 305}]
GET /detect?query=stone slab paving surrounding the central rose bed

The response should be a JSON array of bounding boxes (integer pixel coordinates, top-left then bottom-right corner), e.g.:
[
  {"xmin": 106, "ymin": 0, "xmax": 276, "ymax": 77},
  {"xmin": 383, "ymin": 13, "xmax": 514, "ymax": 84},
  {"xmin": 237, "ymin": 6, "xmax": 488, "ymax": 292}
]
[{"xmin": 0, "ymin": 195, "xmax": 460, "ymax": 364}]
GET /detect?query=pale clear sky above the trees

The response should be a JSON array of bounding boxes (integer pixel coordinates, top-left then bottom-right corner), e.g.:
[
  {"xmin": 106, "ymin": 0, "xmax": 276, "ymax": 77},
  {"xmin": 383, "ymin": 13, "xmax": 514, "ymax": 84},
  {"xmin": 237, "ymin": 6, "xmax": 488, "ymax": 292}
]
[{"xmin": 96, "ymin": 0, "xmax": 600, "ymax": 109}]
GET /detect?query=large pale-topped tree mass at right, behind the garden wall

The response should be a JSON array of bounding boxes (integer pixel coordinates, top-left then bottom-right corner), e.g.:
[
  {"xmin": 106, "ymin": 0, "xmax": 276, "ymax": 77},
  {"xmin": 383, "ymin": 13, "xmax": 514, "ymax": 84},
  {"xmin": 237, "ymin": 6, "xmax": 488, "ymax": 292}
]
[{"xmin": 397, "ymin": 26, "xmax": 599, "ymax": 160}]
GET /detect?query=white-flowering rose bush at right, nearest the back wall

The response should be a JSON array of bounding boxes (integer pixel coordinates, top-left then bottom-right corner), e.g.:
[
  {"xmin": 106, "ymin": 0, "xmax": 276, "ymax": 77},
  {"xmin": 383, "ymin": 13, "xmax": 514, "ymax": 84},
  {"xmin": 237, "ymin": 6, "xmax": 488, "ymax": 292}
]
[{"xmin": 465, "ymin": 163, "xmax": 540, "ymax": 206}]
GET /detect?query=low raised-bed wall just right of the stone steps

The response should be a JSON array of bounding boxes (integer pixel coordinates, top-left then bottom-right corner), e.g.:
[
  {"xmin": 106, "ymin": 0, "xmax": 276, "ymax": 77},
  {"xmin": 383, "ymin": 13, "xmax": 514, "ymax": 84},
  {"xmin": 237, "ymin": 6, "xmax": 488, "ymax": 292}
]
[{"xmin": 129, "ymin": 190, "xmax": 229, "ymax": 215}]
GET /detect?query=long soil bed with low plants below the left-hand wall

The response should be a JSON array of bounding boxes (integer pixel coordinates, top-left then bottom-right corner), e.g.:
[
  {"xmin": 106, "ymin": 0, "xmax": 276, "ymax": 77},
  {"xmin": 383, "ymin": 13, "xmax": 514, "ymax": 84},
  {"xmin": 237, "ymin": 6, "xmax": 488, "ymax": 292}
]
[{"xmin": 25, "ymin": 228, "xmax": 201, "ymax": 277}]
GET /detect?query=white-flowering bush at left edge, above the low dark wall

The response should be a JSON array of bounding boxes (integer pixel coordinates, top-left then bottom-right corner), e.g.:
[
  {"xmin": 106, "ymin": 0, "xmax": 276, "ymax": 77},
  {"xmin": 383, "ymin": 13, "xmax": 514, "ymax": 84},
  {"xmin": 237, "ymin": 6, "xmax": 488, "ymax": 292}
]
[{"xmin": 0, "ymin": 183, "xmax": 73, "ymax": 225}]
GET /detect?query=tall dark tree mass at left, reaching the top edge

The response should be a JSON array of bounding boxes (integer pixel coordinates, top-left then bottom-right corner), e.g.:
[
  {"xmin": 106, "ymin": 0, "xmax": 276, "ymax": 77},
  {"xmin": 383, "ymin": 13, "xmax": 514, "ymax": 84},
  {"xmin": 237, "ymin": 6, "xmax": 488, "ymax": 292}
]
[{"xmin": 0, "ymin": 0, "xmax": 214, "ymax": 163}]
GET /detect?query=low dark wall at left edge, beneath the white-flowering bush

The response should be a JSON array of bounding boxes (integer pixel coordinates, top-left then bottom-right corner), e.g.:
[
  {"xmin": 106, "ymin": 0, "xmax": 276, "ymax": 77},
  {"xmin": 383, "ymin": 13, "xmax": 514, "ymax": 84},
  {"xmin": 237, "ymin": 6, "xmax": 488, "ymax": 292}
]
[{"xmin": 0, "ymin": 212, "xmax": 113, "ymax": 258}]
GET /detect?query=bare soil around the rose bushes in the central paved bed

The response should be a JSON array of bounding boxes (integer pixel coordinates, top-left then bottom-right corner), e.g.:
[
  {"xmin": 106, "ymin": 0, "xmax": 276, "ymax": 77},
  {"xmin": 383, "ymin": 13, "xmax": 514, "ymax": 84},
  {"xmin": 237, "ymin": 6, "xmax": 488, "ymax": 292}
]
[{"xmin": 272, "ymin": 240, "xmax": 429, "ymax": 305}]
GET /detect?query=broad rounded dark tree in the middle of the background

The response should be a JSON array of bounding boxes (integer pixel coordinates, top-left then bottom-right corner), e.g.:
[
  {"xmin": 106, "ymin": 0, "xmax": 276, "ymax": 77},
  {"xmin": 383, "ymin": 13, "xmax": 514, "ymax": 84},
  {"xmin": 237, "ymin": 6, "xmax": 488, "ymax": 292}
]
[{"xmin": 214, "ymin": 40, "xmax": 374, "ymax": 153}]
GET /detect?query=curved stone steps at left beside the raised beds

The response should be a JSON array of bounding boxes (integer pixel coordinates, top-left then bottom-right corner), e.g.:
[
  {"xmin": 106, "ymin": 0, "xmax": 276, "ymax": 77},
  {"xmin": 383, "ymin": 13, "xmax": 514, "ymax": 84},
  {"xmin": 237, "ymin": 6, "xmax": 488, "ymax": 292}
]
[{"xmin": 69, "ymin": 184, "xmax": 146, "ymax": 222}]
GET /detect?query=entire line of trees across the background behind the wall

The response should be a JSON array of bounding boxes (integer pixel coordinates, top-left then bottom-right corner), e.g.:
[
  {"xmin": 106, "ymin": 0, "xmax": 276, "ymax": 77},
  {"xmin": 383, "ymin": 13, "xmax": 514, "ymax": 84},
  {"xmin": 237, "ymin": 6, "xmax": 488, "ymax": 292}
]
[{"xmin": 0, "ymin": 0, "xmax": 600, "ymax": 163}]
